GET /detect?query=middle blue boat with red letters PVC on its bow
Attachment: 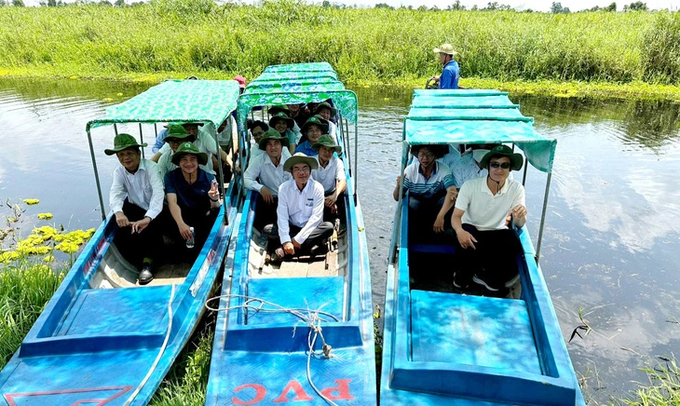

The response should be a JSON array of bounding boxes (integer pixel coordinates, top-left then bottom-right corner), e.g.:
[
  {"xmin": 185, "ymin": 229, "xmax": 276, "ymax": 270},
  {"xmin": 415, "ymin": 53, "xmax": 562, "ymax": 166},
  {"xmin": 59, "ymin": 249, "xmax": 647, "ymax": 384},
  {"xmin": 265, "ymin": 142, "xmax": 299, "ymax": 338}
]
[{"xmin": 206, "ymin": 66, "xmax": 377, "ymax": 406}]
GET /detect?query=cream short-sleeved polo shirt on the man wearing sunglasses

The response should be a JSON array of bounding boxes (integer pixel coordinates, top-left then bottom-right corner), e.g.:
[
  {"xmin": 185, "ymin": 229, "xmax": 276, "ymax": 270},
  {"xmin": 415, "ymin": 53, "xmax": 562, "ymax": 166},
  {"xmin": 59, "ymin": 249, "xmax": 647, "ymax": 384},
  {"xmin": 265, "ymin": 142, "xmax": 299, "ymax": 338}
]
[{"xmin": 456, "ymin": 177, "xmax": 525, "ymax": 231}]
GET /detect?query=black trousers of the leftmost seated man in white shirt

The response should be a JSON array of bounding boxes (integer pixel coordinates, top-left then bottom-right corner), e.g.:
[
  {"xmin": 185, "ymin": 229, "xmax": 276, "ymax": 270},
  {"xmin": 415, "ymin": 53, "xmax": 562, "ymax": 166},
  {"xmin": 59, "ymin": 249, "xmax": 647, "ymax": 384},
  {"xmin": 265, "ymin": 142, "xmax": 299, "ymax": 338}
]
[{"xmin": 113, "ymin": 199, "xmax": 164, "ymax": 267}]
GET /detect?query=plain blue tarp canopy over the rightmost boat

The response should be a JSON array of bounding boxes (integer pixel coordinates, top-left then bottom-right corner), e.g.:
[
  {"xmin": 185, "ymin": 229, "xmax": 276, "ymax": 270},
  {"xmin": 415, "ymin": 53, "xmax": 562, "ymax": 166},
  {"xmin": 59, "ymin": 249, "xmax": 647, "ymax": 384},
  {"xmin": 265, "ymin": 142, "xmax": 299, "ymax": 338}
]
[{"xmin": 403, "ymin": 90, "xmax": 557, "ymax": 172}]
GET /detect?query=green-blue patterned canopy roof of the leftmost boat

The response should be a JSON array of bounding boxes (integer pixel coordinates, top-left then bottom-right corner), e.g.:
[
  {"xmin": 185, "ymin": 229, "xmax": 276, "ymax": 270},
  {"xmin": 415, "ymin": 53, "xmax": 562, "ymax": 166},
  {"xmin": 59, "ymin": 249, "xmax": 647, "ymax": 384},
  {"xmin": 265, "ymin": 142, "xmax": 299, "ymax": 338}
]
[{"xmin": 86, "ymin": 80, "xmax": 239, "ymax": 131}]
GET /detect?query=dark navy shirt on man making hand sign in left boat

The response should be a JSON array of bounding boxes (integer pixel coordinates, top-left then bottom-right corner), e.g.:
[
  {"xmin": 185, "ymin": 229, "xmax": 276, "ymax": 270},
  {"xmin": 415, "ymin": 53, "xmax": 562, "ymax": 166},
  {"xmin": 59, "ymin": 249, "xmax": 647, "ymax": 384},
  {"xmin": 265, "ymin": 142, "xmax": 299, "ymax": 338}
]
[{"xmin": 165, "ymin": 168, "xmax": 215, "ymax": 212}]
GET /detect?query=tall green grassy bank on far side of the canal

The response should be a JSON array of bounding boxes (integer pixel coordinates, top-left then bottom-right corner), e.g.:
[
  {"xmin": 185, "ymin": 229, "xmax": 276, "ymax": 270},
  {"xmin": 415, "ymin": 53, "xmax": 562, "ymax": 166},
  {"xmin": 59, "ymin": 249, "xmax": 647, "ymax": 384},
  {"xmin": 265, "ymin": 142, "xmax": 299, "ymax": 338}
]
[{"xmin": 0, "ymin": 0, "xmax": 680, "ymax": 97}]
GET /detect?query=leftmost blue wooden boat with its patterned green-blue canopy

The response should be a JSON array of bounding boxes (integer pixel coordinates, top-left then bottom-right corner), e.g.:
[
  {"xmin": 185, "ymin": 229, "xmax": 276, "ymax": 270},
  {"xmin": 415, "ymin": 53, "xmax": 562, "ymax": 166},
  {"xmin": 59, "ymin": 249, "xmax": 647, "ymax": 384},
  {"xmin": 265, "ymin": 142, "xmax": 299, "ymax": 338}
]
[{"xmin": 0, "ymin": 80, "xmax": 239, "ymax": 406}]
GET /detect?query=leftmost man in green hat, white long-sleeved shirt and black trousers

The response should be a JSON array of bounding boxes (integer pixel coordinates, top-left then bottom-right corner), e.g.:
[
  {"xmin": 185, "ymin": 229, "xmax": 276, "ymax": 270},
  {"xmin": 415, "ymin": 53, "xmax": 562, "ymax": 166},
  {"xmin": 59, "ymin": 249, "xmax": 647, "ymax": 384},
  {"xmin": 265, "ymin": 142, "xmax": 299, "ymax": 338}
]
[{"xmin": 104, "ymin": 134, "xmax": 164, "ymax": 285}]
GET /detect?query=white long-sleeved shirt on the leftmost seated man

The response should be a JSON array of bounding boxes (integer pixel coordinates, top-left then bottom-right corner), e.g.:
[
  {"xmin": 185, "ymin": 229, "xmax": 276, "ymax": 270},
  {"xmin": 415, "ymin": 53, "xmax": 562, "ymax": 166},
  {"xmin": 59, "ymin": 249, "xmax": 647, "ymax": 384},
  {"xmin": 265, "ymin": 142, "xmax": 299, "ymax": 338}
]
[{"xmin": 109, "ymin": 159, "xmax": 165, "ymax": 219}]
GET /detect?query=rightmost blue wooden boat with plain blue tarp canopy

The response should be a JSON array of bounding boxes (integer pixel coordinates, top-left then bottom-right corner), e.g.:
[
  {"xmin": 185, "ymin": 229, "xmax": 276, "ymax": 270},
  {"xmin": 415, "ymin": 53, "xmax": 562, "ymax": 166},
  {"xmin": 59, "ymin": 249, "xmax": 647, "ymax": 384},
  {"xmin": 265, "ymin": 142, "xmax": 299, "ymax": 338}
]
[{"xmin": 380, "ymin": 90, "xmax": 585, "ymax": 406}]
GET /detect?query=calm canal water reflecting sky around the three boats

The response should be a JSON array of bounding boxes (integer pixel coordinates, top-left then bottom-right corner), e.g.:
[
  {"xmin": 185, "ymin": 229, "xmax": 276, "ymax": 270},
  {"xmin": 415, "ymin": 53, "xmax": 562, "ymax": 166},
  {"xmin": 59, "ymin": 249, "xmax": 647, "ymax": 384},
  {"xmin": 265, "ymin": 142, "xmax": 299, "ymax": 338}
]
[{"xmin": 0, "ymin": 79, "xmax": 680, "ymax": 404}]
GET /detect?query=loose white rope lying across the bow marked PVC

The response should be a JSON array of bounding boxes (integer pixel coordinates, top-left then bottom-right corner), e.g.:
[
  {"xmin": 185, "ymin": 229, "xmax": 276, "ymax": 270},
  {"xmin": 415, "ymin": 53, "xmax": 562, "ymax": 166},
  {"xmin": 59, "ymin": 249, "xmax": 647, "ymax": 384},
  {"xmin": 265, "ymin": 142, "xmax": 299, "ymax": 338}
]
[{"xmin": 205, "ymin": 294, "xmax": 340, "ymax": 406}]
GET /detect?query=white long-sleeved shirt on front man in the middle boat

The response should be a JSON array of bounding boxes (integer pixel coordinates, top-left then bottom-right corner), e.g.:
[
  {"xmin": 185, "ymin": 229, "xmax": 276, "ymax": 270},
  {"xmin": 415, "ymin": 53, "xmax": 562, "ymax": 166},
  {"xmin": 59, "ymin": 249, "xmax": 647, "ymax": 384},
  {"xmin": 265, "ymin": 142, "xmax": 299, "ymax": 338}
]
[{"xmin": 276, "ymin": 178, "xmax": 324, "ymax": 244}]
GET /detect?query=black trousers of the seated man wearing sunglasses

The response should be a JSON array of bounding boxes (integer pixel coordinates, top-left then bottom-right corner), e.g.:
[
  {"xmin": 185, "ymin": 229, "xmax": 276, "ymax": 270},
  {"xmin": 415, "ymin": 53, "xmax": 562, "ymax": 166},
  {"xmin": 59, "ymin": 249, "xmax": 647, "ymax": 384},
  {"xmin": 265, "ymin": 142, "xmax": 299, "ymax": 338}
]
[{"xmin": 455, "ymin": 224, "xmax": 522, "ymax": 288}]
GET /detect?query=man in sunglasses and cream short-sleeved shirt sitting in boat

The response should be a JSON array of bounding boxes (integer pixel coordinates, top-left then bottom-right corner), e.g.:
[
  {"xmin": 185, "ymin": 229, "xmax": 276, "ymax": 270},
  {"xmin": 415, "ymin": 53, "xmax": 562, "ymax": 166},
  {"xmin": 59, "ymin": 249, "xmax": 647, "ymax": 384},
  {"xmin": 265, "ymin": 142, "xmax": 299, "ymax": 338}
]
[{"xmin": 451, "ymin": 145, "xmax": 527, "ymax": 297}]
